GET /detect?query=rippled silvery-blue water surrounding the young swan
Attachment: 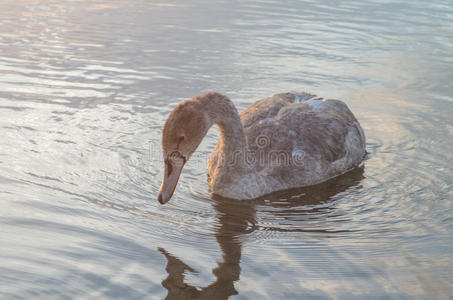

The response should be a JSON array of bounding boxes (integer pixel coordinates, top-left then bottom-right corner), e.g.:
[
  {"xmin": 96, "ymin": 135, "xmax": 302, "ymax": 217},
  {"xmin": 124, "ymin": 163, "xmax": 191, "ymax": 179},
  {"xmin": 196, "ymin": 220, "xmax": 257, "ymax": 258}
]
[{"xmin": 0, "ymin": 0, "xmax": 453, "ymax": 299}]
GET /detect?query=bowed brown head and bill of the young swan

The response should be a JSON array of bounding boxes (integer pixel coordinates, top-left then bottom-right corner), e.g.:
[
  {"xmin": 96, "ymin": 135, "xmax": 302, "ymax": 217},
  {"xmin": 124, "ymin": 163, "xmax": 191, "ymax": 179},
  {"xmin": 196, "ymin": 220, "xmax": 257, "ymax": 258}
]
[{"xmin": 158, "ymin": 100, "xmax": 212, "ymax": 204}]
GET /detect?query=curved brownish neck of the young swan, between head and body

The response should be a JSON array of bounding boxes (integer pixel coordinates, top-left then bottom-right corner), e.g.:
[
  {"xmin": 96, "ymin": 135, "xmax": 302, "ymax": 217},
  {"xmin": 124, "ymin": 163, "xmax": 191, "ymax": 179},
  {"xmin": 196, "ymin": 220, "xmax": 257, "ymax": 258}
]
[{"xmin": 200, "ymin": 93, "xmax": 253, "ymax": 172}]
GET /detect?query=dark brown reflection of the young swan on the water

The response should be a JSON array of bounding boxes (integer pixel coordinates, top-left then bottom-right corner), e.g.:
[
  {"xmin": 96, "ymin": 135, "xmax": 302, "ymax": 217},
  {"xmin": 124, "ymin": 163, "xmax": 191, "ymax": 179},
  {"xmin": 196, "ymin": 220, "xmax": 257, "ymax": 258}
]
[{"xmin": 158, "ymin": 166, "xmax": 364, "ymax": 300}]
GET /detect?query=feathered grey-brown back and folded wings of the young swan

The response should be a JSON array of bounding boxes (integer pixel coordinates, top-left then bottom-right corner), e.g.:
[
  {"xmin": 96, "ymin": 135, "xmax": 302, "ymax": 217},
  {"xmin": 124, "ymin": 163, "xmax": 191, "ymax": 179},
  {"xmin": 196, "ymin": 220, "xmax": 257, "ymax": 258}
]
[{"xmin": 240, "ymin": 93, "xmax": 366, "ymax": 190}]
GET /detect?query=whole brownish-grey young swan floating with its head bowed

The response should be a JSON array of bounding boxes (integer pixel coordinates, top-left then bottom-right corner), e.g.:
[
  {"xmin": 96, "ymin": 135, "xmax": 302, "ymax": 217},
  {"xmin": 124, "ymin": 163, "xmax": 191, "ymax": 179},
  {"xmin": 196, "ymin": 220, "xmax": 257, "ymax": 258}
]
[{"xmin": 158, "ymin": 92, "xmax": 366, "ymax": 204}]
